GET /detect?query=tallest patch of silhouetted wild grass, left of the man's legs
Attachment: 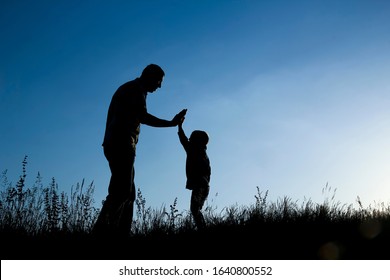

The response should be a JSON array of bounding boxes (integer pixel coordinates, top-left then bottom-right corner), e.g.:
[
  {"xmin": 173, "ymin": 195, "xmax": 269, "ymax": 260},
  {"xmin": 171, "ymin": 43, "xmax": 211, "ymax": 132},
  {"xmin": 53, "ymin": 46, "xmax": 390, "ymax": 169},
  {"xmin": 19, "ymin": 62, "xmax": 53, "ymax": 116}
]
[{"xmin": 0, "ymin": 156, "xmax": 99, "ymax": 236}]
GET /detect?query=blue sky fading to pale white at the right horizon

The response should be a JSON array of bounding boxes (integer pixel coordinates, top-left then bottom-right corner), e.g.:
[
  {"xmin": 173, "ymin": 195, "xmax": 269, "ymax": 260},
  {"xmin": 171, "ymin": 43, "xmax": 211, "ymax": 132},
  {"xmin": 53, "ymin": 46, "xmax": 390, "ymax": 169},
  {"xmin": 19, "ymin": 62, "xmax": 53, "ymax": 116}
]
[{"xmin": 0, "ymin": 0, "xmax": 390, "ymax": 214}]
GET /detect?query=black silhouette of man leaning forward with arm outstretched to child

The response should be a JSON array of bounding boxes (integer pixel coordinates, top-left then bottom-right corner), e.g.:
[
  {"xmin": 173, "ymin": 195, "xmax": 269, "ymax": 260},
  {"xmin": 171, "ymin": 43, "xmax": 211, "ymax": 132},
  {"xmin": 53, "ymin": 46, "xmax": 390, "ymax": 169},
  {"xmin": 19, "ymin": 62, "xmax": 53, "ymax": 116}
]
[{"xmin": 93, "ymin": 64, "xmax": 187, "ymax": 237}]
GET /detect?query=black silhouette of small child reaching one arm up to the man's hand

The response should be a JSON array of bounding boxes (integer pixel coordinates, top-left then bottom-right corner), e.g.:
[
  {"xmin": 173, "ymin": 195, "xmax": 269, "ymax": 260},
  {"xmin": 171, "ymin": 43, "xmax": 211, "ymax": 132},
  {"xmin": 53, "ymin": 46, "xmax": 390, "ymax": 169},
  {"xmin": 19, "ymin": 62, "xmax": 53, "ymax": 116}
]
[{"xmin": 178, "ymin": 117, "xmax": 211, "ymax": 229}]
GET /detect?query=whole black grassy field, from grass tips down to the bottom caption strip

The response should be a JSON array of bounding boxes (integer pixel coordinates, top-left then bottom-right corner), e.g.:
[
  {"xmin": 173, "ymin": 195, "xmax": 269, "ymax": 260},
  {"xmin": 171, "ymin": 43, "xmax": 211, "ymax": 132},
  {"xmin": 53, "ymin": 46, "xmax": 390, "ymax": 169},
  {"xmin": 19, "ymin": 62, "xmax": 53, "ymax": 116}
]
[{"xmin": 0, "ymin": 158, "xmax": 390, "ymax": 260}]
